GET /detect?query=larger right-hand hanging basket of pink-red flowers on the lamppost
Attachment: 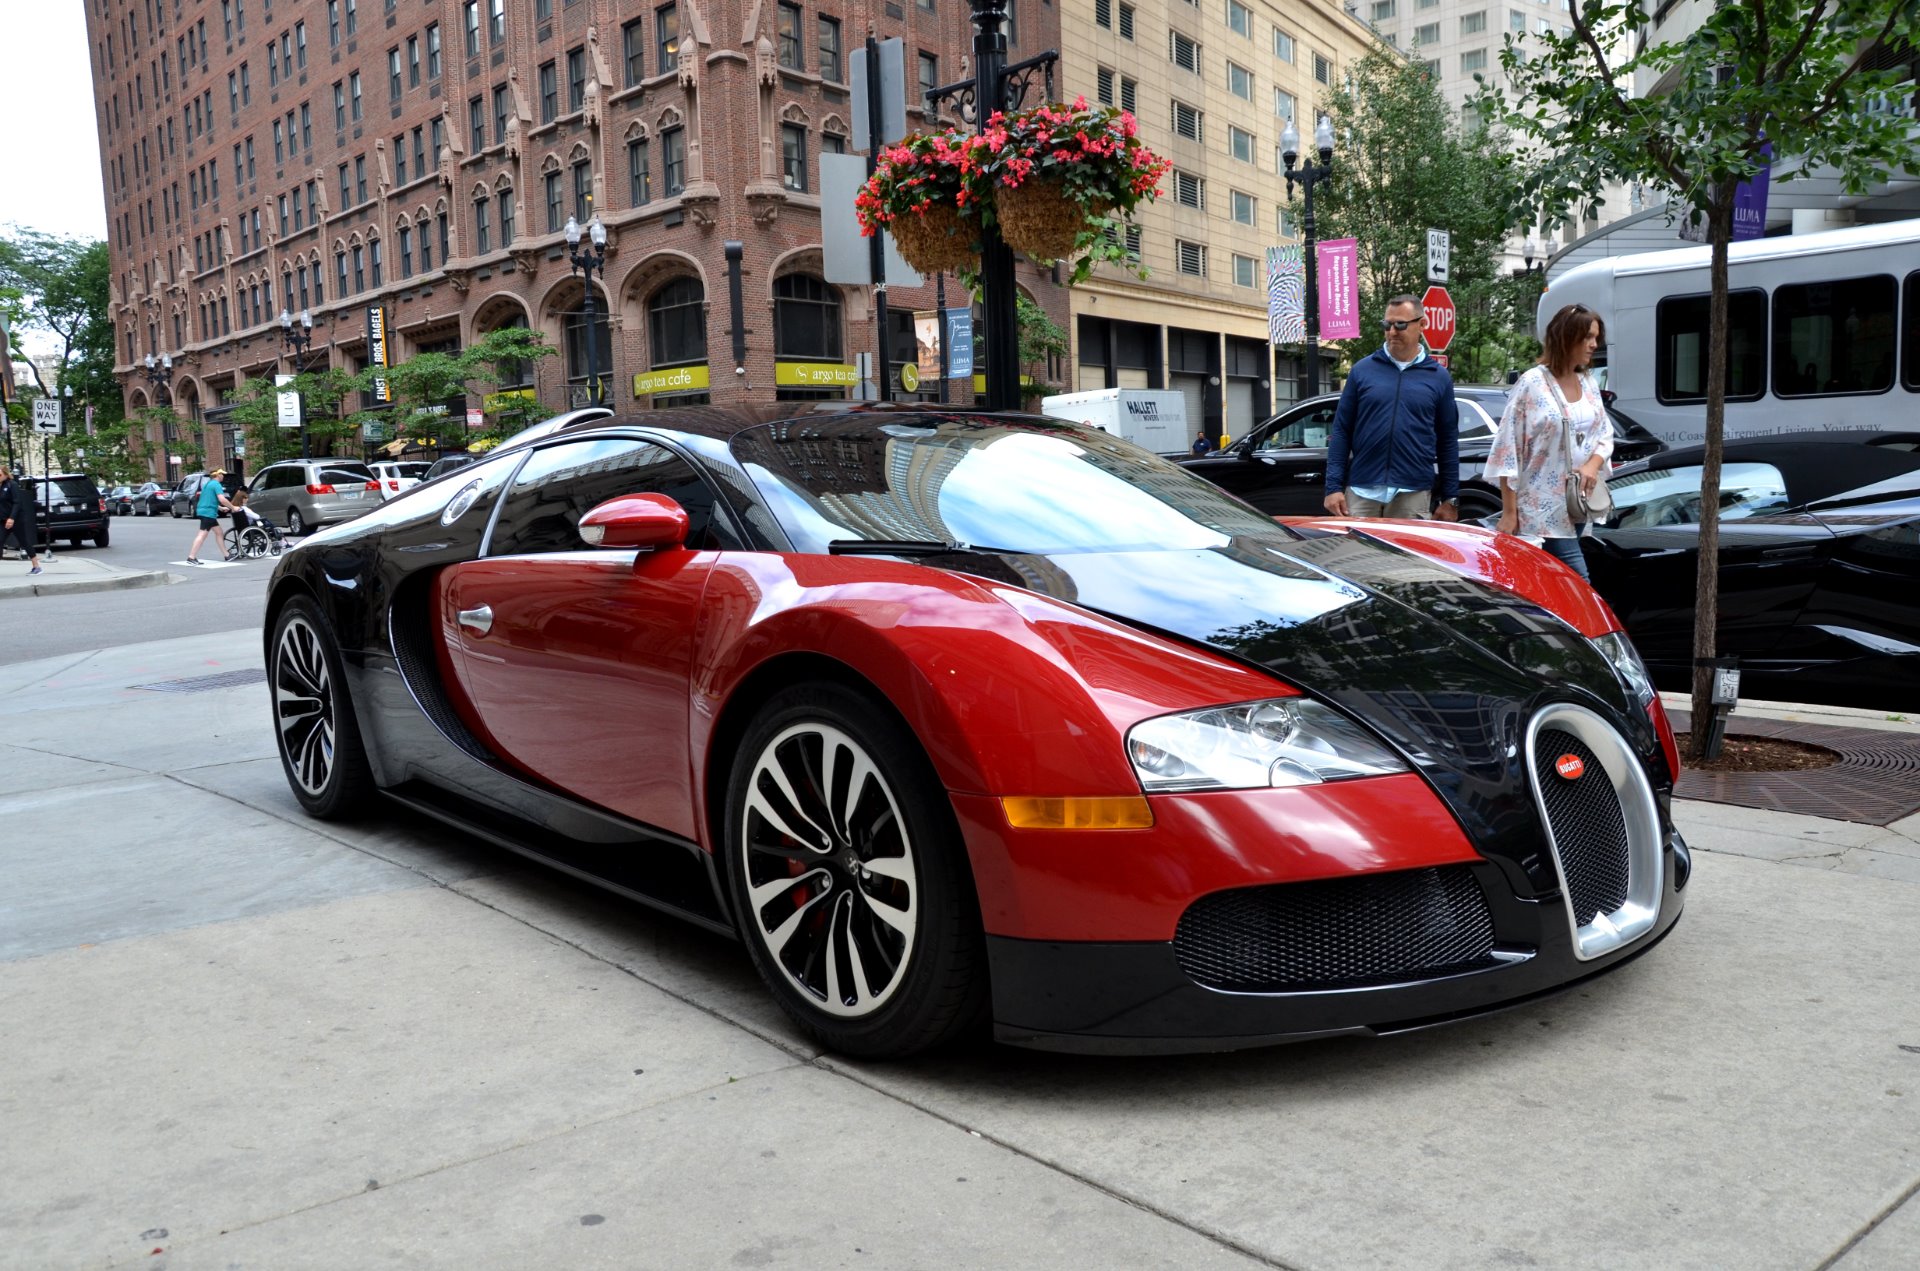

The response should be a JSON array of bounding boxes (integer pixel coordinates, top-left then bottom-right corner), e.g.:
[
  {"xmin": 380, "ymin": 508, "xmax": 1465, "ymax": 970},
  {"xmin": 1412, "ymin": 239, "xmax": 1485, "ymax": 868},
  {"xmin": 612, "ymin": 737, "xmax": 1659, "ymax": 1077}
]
[{"xmin": 972, "ymin": 98, "xmax": 1173, "ymax": 282}]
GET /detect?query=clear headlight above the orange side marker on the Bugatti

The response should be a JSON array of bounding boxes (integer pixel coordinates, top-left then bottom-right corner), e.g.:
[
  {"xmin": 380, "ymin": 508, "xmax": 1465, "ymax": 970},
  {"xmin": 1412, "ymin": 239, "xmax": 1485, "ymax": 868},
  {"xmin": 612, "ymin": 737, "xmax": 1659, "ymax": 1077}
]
[{"xmin": 1127, "ymin": 697, "xmax": 1407, "ymax": 793}]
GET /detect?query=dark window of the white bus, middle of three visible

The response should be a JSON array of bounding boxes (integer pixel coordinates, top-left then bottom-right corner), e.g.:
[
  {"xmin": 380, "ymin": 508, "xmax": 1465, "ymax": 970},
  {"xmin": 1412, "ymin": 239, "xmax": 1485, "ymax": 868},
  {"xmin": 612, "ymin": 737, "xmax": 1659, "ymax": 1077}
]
[{"xmin": 1774, "ymin": 275, "xmax": 1899, "ymax": 397}]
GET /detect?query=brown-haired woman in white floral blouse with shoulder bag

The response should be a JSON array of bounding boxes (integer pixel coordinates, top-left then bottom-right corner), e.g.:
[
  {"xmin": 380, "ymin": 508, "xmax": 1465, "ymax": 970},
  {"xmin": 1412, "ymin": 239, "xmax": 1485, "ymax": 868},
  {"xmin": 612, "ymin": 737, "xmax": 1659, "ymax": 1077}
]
[{"xmin": 1486, "ymin": 305, "xmax": 1613, "ymax": 578}]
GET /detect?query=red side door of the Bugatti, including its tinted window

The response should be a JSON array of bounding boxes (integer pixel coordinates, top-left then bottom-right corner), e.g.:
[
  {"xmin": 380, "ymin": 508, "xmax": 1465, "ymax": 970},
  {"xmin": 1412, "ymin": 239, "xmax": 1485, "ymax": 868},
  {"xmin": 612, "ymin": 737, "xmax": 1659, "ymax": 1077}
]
[{"xmin": 436, "ymin": 438, "xmax": 733, "ymax": 839}]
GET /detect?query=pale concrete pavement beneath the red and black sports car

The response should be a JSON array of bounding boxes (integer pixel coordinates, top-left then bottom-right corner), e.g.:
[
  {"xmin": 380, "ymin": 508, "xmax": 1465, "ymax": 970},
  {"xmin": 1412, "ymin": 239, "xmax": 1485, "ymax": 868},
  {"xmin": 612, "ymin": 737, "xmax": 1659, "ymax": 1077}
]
[{"xmin": 0, "ymin": 632, "xmax": 1920, "ymax": 1271}]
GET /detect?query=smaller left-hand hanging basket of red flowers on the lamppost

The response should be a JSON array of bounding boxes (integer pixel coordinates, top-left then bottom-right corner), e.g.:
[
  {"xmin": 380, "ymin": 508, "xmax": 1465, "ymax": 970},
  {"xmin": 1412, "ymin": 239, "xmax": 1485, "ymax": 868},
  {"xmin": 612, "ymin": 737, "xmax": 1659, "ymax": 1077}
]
[{"xmin": 852, "ymin": 131, "xmax": 987, "ymax": 273}]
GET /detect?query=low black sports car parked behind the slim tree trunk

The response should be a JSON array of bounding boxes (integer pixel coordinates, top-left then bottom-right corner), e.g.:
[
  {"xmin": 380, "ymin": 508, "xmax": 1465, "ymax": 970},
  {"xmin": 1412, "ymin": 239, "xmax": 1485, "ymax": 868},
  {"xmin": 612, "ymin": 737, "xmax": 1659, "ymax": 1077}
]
[{"xmin": 1586, "ymin": 432, "xmax": 1920, "ymax": 710}]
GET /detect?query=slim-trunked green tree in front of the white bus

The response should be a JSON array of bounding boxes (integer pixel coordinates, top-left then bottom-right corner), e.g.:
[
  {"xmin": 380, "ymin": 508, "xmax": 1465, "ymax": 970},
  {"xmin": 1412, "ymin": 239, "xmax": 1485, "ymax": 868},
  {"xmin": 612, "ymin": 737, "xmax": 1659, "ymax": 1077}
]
[{"xmin": 1478, "ymin": 0, "xmax": 1920, "ymax": 758}]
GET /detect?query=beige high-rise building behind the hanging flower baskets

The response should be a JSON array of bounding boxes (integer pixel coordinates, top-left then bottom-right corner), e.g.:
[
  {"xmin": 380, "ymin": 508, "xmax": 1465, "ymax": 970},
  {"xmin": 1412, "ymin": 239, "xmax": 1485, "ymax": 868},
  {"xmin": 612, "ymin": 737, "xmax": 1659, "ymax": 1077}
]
[{"xmin": 1060, "ymin": 0, "xmax": 1373, "ymax": 436}]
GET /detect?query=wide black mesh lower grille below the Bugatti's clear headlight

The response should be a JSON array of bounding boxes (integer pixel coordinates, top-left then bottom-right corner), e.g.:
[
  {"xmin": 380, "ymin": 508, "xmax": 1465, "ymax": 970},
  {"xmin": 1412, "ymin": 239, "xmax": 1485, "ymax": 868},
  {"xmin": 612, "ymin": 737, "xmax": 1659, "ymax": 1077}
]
[{"xmin": 1173, "ymin": 864, "xmax": 1498, "ymax": 993}]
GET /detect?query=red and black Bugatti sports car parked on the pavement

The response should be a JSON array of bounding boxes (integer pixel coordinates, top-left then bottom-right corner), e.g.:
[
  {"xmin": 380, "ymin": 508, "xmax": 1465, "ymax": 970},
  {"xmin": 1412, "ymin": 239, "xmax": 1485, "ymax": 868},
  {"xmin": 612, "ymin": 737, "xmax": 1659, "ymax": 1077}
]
[{"xmin": 265, "ymin": 403, "xmax": 1690, "ymax": 1056}]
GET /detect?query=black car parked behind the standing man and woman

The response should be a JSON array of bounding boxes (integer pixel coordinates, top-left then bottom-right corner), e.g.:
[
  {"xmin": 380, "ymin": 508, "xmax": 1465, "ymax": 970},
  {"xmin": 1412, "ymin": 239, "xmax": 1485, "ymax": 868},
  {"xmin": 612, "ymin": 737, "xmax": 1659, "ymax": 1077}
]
[{"xmin": 1181, "ymin": 384, "xmax": 1663, "ymax": 520}]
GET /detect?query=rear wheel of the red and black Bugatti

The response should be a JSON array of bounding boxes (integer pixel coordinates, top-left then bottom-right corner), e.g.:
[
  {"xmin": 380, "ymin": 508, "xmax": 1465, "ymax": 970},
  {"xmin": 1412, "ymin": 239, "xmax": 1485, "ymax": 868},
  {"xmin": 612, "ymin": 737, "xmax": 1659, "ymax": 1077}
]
[{"xmin": 267, "ymin": 595, "xmax": 374, "ymax": 820}]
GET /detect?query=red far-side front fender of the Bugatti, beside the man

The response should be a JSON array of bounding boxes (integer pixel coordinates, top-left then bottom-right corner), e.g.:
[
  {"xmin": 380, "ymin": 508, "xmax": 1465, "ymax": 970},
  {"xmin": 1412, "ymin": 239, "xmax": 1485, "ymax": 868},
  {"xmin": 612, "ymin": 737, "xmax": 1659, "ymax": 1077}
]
[{"xmin": 1275, "ymin": 516, "xmax": 1624, "ymax": 639}]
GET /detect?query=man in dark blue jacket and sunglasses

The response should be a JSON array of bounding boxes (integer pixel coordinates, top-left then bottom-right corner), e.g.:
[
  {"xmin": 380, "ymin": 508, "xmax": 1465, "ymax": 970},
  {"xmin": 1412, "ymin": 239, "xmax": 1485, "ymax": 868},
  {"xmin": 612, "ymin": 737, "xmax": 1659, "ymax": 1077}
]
[{"xmin": 1327, "ymin": 296, "xmax": 1459, "ymax": 520}]
